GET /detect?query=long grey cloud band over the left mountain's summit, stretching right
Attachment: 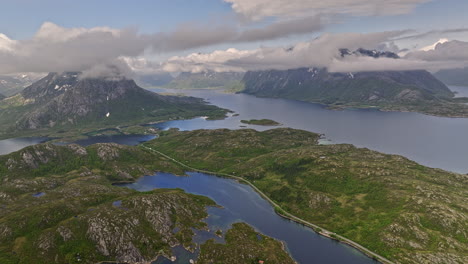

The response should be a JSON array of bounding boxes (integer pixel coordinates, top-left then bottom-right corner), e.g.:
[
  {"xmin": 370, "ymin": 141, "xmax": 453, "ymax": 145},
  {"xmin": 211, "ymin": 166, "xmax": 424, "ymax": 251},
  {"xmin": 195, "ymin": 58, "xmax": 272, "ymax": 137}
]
[{"xmin": 0, "ymin": 17, "xmax": 323, "ymax": 74}]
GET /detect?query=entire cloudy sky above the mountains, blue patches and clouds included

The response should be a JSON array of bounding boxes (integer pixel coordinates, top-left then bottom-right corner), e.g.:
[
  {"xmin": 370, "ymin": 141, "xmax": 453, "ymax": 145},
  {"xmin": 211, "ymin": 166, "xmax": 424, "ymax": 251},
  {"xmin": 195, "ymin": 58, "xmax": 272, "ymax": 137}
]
[{"xmin": 0, "ymin": 0, "xmax": 468, "ymax": 74}]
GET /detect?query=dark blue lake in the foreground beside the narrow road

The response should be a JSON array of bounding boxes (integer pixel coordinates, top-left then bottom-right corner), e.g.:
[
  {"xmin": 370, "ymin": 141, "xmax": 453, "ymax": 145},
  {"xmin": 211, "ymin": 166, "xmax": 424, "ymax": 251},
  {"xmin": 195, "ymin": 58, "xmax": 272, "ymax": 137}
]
[{"xmin": 124, "ymin": 173, "xmax": 376, "ymax": 264}]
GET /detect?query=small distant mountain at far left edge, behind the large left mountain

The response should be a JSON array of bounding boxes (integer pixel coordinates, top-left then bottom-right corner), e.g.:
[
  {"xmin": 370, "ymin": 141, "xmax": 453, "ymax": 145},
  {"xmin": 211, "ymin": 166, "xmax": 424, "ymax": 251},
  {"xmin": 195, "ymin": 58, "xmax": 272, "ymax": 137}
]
[{"xmin": 0, "ymin": 74, "xmax": 44, "ymax": 96}]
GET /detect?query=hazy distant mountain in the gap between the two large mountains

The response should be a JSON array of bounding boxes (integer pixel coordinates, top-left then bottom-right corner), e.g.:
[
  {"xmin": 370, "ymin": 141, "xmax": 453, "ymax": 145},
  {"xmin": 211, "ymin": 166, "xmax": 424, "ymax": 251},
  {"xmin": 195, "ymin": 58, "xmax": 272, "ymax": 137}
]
[{"xmin": 165, "ymin": 71, "xmax": 244, "ymax": 89}]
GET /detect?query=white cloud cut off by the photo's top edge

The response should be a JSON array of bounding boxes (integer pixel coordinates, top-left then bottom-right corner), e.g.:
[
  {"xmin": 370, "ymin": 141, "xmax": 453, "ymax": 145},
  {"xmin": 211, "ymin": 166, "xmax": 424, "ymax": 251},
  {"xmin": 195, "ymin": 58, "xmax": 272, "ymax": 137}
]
[{"xmin": 224, "ymin": 0, "xmax": 431, "ymax": 21}]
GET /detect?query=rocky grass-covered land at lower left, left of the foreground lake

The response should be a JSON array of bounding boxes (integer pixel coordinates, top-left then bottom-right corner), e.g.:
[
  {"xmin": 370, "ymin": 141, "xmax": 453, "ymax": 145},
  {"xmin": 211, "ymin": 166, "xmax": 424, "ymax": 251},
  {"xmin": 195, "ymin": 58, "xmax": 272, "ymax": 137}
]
[{"xmin": 0, "ymin": 144, "xmax": 298, "ymax": 264}]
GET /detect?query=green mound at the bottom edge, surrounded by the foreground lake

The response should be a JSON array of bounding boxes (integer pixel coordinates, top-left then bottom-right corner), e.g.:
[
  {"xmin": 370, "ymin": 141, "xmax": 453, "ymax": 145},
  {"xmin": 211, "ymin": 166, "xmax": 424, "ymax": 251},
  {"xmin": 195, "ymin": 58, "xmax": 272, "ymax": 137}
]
[{"xmin": 197, "ymin": 223, "xmax": 295, "ymax": 264}]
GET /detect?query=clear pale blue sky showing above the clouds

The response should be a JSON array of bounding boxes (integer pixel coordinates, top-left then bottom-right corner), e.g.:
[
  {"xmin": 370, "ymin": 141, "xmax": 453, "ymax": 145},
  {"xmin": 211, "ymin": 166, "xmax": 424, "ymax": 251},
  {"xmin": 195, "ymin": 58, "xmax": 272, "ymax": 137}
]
[{"xmin": 0, "ymin": 0, "xmax": 468, "ymax": 42}]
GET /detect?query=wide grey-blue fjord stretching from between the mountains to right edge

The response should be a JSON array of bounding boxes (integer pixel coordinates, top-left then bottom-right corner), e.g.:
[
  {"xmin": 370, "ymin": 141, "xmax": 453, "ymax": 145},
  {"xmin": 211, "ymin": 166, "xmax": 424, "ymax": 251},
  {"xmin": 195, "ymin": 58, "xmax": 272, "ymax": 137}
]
[{"xmin": 149, "ymin": 88, "xmax": 468, "ymax": 173}]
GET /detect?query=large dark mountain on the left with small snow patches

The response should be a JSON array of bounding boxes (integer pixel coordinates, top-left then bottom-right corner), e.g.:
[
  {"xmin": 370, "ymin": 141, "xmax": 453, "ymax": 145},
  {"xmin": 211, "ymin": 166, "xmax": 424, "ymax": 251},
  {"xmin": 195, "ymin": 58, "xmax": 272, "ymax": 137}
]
[{"xmin": 0, "ymin": 72, "xmax": 225, "ymax": 138}]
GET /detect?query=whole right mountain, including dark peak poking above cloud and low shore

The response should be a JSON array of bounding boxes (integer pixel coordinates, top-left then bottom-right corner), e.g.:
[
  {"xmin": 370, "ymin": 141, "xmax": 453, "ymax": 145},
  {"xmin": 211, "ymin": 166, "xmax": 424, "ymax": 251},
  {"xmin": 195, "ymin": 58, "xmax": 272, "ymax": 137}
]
[{"xmin": 242, "ymin": 49, "xmax": 468, "ymax": 116}]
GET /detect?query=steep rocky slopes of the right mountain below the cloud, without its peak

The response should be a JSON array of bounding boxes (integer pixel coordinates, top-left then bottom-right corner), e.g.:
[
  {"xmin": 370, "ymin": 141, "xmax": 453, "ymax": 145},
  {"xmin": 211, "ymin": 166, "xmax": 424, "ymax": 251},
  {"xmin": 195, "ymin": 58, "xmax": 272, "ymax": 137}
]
[{"xmin": 243, "ymin": 68, "xmax": 453, "ymax": 106}]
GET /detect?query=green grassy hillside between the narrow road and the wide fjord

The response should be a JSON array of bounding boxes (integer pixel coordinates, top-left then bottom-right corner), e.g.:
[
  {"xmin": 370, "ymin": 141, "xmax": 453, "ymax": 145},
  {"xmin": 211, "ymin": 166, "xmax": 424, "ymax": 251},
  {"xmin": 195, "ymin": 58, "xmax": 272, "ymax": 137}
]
[{"xmin": 145, "ymin": 129, "xmax": 468, "ymax": 263}]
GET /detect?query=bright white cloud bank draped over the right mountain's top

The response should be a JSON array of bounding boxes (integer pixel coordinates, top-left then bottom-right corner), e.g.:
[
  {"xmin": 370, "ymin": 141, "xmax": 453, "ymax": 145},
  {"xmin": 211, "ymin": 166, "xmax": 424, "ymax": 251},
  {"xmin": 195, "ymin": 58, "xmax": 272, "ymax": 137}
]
[{"xmin": 158, "ymin": 31, "xmax": 468, "ymax": 72}]
